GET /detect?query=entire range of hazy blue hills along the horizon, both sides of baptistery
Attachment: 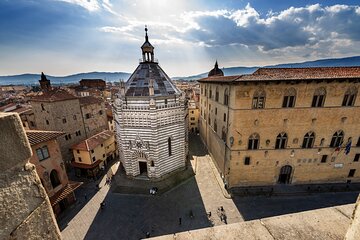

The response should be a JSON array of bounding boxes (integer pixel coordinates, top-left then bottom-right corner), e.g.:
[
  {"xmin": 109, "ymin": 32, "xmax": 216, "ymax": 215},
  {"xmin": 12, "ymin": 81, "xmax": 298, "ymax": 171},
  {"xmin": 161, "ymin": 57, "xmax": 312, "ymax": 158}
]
[{"xmin": 0, "ymin": 56, "xmax": 360, "ymax": 85}]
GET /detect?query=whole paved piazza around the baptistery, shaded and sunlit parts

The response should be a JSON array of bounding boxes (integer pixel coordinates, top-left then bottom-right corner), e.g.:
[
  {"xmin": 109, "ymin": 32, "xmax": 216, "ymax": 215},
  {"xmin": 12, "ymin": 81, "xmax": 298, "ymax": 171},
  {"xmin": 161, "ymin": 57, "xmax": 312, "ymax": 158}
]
[{"xmin": 59, "ymin": 136, "xmax": 358, "ymax": 240}]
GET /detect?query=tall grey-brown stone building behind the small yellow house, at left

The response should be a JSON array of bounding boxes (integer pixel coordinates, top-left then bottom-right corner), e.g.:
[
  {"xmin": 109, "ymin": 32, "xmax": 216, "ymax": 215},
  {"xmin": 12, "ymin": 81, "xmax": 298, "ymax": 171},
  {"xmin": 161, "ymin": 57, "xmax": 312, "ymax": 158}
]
[{"xmin": 30, "ymin": 76, "xmax": 107, "ymax": 163}]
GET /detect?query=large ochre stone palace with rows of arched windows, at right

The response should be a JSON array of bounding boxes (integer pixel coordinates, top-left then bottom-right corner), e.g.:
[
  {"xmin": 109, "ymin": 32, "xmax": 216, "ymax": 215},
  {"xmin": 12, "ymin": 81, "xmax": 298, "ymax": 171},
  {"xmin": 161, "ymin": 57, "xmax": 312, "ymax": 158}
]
[{"xmin": 199, "ymin": 66, "xmax": 360, "ymax": 188}]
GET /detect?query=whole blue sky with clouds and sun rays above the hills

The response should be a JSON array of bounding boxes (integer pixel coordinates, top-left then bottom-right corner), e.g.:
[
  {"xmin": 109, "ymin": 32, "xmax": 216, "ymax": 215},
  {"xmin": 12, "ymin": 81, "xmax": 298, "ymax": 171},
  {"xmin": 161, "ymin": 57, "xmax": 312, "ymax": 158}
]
[{"xmin": 0, "ymin": 0, "xmax": 360, "ymax": 77}]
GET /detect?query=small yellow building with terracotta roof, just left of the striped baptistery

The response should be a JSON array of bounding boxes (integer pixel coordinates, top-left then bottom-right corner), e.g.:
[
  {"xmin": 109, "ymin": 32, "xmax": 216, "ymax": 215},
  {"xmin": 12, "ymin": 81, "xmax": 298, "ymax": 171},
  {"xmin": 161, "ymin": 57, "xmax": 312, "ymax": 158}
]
[{"xmin": 72, "ymin": 130, "xmax": 117, "ymax": 177}]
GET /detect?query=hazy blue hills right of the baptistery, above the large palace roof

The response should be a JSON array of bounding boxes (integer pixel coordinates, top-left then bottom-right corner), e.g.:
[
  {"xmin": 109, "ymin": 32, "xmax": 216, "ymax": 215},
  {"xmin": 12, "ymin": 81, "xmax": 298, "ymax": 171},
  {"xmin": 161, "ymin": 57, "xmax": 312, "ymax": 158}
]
[{"xmin": 172, "ymin": 56, "xmax": 360, "ymax": 80}]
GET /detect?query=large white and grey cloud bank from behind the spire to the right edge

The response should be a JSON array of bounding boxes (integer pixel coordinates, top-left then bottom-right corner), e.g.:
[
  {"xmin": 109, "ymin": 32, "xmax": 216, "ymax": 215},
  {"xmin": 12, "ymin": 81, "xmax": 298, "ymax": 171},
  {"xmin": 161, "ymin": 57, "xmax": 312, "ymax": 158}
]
[{"xmin": 100, "ymin": 4, "xmax": 360, "ymax": 68}]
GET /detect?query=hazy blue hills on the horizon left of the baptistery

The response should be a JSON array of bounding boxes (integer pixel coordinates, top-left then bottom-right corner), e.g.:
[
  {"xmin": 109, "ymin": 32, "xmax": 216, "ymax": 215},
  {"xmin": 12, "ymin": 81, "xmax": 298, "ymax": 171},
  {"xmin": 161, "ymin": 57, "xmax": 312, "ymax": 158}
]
[{"xmin": 0, "ymin": 72, "xmax": 130, "ymax": 85}]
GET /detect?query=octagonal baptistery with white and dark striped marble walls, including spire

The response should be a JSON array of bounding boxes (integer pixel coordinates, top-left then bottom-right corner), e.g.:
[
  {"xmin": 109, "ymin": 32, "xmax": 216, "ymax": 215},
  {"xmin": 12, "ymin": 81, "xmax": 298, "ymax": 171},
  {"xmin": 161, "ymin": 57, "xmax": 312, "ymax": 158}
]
[{"xmin": 114, "ymin": 28, "xmax": 187, "ymax": 179}]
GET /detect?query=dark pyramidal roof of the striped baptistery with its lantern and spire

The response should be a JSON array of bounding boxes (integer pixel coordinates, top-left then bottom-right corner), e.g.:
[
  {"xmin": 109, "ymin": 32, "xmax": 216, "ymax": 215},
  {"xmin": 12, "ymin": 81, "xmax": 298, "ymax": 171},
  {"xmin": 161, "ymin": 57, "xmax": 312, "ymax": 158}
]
[{"xmin": 125, "ymin": 28, "xmax": 181, "ymax": 97}]
